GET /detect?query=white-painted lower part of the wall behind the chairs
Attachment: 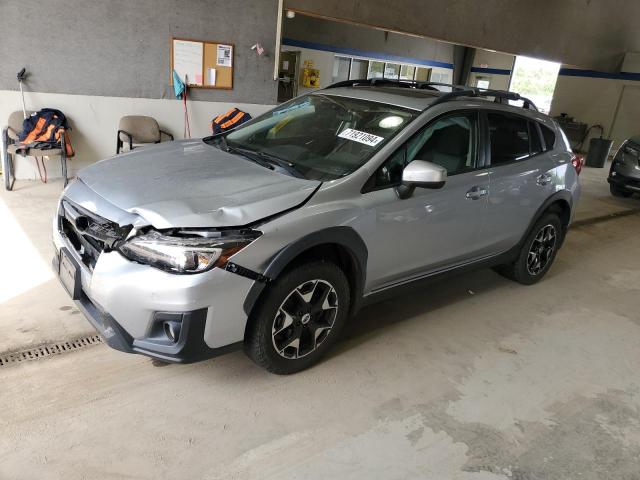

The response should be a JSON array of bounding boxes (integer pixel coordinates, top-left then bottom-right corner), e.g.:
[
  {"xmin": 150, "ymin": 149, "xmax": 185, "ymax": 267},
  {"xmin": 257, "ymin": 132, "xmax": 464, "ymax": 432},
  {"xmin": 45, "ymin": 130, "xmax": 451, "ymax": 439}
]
[{"xmin": 0, "ymin": 90, "xmax": 272, "ymax": 180}]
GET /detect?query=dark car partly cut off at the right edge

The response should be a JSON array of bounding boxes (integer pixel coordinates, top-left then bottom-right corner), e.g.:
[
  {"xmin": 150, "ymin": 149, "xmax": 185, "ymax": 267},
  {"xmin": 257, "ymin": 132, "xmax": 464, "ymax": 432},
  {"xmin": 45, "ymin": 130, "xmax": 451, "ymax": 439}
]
[{"xmin": 607, "ymin": 135, "xmax": 640, "ymax": 197}]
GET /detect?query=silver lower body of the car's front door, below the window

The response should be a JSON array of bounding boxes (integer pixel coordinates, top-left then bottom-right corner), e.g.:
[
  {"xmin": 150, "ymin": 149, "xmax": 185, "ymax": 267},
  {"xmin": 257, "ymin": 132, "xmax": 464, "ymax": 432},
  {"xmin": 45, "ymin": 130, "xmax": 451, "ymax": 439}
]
[{"xmin": 366, "ymin": 171, "xmax": 489, "ymax": 289}]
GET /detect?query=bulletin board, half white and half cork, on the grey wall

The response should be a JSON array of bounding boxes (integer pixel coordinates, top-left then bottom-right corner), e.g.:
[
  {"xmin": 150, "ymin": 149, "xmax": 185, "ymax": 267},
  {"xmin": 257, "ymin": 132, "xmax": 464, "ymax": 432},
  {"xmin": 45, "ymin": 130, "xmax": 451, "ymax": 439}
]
[{"xmin": 169, "ymin": 38, "xmax": 235, "ymax": 90}]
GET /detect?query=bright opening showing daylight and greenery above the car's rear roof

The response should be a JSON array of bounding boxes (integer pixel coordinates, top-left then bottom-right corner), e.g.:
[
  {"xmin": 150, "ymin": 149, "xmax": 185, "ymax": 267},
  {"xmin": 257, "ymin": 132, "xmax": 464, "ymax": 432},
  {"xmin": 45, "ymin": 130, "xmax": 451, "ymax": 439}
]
[{"xmin": 509, "ymin": 56, "xmax": 560, "ymax": 113}]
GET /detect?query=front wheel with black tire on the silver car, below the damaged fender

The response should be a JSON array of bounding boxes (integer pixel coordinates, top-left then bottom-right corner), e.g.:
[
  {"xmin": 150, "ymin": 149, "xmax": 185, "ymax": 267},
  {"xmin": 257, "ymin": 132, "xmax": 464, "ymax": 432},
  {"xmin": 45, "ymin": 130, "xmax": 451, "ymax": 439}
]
[{"xmin": 244, "ymin": 261, "xmax": 351, "ymax": 375}]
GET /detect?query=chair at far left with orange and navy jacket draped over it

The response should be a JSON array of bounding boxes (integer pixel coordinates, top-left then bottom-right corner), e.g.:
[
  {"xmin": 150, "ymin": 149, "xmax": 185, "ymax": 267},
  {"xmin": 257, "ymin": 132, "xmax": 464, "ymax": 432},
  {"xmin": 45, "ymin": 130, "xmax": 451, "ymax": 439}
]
[{"xmin": 2, "ymin": 110, "xmax": 69, "ymax": 190}]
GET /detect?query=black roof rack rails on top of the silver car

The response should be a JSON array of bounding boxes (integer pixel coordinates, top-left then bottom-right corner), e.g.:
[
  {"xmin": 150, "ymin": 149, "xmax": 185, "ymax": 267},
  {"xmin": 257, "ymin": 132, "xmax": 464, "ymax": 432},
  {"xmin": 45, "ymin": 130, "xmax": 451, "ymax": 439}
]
[{"xmin": 326, "ymin": 78, "xmax": 538, "ymax": 112}]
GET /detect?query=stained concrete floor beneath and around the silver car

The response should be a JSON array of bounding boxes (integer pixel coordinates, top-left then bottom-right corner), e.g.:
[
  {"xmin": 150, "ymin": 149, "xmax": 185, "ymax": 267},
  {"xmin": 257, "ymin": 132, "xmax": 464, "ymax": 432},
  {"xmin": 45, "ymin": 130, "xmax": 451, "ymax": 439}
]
[{"xmin": 0, "ymin": 170, "xmax": 640, "ymax": 480}]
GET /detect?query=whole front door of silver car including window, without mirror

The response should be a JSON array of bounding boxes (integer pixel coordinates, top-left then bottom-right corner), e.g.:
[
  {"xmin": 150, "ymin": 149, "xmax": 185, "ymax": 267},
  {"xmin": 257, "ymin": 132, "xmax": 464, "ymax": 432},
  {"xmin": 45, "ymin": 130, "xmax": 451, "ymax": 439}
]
[{"xmin": 365, "ymin": 111, "xmax": 489, "ymax": 289}]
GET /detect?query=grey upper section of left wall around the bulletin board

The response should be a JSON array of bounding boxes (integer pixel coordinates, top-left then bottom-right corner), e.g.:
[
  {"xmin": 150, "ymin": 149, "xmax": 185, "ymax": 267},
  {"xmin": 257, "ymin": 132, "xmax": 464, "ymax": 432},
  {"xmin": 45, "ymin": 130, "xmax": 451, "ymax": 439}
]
[{"xmin": 0, "ymin": 0, "xmax": 277, "ymax": 103}]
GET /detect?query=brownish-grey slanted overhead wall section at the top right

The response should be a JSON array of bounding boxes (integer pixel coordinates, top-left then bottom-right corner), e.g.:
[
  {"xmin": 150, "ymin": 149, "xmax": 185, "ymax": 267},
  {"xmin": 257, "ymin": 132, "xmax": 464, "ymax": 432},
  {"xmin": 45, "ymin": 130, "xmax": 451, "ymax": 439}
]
[{"xmin": 285, "ymin": 0, "xmax": 640, "ymax": 71}]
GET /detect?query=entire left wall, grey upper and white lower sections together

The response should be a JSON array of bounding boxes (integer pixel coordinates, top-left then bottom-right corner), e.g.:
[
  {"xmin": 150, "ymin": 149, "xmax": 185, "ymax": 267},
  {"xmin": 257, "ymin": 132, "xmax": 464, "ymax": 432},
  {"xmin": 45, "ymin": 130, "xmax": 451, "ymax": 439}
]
[{"xmin": 0, "ymin": 0, "xmax": 277, "ymax": 178}]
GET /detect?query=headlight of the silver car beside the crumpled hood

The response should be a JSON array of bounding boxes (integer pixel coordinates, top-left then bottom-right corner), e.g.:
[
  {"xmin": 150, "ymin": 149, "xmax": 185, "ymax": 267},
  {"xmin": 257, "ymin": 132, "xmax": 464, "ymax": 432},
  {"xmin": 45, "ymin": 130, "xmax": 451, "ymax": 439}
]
[{"xmin": 119, "ymin": 230, "xmax": 260, "ymax": 273}]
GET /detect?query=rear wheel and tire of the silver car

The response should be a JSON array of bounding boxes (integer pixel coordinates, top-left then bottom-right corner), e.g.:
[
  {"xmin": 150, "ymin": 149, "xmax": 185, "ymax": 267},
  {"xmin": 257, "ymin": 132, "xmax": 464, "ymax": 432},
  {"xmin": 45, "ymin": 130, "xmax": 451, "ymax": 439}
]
[{"xmin": 495, "ymin": 213, "xmax": 564, "ymax": 285}]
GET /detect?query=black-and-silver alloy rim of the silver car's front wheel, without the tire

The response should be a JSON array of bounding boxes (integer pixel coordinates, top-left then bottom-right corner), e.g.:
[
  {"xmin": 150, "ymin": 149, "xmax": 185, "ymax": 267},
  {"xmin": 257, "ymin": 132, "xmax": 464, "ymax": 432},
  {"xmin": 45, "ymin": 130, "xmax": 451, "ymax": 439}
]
[{"xmin": 271, "ymin": 280, "xmax": 338, "ymax": 359}]
